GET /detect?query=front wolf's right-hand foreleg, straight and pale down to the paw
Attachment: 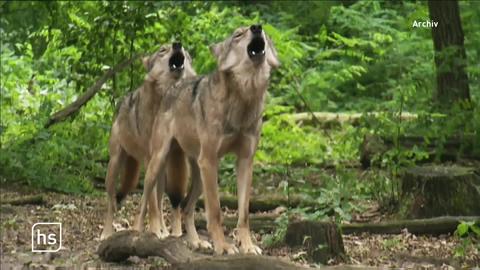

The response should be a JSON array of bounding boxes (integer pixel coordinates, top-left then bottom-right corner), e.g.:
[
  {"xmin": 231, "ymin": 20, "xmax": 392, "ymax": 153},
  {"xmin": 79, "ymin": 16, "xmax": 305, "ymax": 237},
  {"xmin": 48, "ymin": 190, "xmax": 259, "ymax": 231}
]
[{"xmin": 236, "ymin": 142, "xmax": 262, "ymax": 254}]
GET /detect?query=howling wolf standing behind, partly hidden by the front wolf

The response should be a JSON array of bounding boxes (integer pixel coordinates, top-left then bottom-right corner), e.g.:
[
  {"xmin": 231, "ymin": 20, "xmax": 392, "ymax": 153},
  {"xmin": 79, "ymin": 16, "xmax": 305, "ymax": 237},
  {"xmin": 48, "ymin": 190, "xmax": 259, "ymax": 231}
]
[{"xmin": 101, "ymin": 43, "xmax": 196, "ymax": 239}]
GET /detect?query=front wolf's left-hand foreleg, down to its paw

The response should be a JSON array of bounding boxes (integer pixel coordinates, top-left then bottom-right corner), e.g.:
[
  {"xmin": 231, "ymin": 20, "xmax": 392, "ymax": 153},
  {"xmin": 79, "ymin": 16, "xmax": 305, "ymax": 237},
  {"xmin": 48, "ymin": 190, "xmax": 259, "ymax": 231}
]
[{"xmin": 198, "ymin": 152, "xmax": 238, "ymax": 255}]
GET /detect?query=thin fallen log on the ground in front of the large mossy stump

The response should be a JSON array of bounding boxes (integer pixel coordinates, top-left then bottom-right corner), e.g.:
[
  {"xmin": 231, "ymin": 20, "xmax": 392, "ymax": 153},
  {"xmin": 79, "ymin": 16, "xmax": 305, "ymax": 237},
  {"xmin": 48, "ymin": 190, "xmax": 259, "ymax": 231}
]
[{"xmin": 341, "ymin": 216, "xmax": 480, "ymax": 235}]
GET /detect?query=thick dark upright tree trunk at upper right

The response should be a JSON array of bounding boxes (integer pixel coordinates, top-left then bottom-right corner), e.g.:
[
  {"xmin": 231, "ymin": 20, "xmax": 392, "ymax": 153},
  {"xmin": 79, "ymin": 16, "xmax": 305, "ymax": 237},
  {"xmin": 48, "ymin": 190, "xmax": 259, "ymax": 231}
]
[{"xmin": 428, "ymin": 0, "xmax": 470, "ymax": 106}]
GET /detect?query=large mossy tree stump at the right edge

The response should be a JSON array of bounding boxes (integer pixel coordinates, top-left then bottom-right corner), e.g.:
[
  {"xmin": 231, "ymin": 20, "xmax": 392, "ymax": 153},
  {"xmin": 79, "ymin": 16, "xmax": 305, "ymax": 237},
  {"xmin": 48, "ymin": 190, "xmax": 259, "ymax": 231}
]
[{"xmin": 400, "ymin": 165, "xmax": 480, "ymax": 218}]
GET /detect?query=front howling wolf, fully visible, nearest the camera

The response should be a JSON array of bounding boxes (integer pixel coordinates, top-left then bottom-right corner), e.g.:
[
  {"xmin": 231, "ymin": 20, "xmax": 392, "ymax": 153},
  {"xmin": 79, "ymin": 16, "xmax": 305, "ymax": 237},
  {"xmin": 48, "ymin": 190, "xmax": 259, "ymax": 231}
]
[{"xmin": 134, "ymin": 25, "xmax": 280, "ymax": 254}]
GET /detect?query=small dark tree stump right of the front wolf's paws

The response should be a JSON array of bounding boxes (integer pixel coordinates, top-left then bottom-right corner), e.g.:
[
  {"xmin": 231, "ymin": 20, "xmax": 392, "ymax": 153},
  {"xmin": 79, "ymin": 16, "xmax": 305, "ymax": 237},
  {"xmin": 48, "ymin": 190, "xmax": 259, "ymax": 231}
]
[{"xmin": 285, "ymin": 221, "xmax": 345, "ymax": 264}]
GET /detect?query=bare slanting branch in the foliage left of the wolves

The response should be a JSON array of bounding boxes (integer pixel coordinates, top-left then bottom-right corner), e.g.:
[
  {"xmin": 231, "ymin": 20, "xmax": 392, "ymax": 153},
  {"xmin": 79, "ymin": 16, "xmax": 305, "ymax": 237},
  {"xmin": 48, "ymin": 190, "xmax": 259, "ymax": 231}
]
[{"xmin": 45, "ymin": 55, "xmax": 141, "ymax": 128}]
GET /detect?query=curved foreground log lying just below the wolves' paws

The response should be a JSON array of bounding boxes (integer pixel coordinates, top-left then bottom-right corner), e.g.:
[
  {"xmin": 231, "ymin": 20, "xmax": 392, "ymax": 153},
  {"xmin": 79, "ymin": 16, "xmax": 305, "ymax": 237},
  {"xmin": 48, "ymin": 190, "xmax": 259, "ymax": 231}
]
[{"xmin": 97, "ymin": 231, "xmax": 314, "ymax": 270}]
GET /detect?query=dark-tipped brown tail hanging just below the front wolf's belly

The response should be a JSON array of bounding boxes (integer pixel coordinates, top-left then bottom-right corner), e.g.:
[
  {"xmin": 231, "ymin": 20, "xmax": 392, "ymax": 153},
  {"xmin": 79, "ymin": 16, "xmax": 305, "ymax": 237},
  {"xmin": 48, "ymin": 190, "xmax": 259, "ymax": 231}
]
[{"xmin": 165, "ymin": 145, "xmax": 188, "ymax": 208}]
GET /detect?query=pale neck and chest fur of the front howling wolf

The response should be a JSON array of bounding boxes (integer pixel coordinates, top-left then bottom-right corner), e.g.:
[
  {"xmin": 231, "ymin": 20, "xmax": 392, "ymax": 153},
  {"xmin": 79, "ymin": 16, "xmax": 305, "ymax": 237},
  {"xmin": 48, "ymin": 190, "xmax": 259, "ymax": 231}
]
[{"xmin": 213, "ymin": 66, "xmax": 270, "ymax": 133}]
